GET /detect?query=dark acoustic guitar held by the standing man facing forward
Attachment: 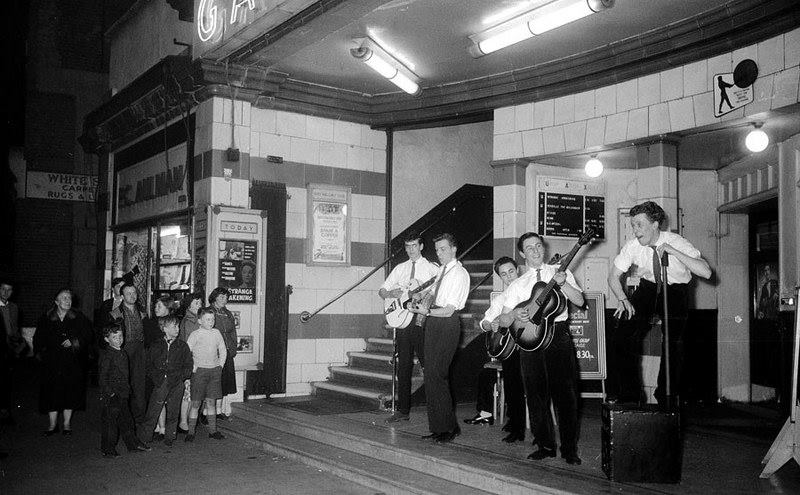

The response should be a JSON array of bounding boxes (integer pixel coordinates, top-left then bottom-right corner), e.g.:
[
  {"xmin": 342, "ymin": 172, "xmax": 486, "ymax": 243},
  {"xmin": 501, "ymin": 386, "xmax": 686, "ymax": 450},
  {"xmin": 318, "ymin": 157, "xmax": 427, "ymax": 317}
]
[{"xmin": 510, "ymin": 228, "xmax": 595, "ymax": 351}]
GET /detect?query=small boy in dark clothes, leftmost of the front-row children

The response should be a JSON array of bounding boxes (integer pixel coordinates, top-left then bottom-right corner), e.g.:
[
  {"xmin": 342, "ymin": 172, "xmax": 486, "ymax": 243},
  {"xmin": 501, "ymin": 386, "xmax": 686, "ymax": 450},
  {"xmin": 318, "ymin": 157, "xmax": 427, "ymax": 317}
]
[{"xmin": 98, "ymin": 325, "xmax": 152, "ymax": 457}]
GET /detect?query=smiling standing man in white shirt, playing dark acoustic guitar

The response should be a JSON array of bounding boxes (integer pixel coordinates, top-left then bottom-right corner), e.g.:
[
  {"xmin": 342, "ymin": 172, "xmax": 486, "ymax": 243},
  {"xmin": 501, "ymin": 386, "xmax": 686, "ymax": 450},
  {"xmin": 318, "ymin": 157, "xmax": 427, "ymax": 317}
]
[{"xmin": 500, "ymin": 232, "xmax": 584, "ymax": 464}]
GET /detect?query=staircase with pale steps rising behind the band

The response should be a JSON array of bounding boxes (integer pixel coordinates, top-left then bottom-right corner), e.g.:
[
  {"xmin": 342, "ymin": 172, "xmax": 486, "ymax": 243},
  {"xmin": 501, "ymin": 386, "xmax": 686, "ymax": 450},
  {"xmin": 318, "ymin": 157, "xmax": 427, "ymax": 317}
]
[{"xmin": 311, "ymin": 260, "xmax": 492, "ymax": 409}]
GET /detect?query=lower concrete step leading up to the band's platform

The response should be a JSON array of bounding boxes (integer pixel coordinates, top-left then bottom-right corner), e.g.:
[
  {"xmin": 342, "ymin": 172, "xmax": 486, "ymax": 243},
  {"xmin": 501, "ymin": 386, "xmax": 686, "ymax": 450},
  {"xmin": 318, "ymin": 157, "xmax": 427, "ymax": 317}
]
[{"xmin": 221, "ymin": 412, "xmax": 487, "ymax": 495}]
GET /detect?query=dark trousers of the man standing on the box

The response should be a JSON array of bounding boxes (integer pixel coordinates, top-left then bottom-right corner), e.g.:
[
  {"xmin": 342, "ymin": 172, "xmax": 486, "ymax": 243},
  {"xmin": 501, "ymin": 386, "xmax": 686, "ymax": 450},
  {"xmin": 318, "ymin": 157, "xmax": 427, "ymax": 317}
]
[{"xmin": 607, "ymin": 280, "xmax": 688, "ymax": 404}]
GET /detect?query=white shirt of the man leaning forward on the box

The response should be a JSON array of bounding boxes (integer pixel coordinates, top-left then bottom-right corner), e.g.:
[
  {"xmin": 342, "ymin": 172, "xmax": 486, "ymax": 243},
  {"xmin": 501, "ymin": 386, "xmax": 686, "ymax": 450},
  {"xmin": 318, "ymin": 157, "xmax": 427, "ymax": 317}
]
[{"xmin": 614, "ymin": 232, "xmax": 700, "ymax": 284}]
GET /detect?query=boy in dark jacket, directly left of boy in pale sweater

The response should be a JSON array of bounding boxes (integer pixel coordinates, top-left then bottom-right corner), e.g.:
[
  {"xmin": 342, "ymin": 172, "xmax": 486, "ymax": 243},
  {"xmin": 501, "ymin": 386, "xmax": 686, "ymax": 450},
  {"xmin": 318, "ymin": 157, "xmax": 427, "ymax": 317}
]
[{"xmin": 138, "ymin": 315, "xmax": 192, "ymax": 447}]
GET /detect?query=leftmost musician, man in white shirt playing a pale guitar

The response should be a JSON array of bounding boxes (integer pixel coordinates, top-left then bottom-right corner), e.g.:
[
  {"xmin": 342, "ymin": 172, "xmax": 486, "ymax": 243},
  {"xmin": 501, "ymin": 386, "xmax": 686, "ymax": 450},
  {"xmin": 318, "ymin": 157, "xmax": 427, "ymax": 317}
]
[{"xmin": 378, "ymin": 233, "xmax": 439, "ymax": 423}]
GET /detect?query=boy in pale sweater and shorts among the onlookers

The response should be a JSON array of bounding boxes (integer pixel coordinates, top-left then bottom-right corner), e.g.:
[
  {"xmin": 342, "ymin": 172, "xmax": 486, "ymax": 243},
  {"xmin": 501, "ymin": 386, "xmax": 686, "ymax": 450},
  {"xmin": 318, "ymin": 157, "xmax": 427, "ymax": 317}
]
[{"xmin": 184, "ymin": 308, "xmax": 228, "ymax": 442}]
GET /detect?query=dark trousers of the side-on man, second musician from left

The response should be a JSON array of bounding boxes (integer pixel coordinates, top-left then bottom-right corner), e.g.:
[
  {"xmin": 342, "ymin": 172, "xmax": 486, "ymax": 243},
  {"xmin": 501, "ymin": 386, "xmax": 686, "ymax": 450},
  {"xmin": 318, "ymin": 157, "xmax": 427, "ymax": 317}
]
[{"xmin": 425, "ymin": 313, "xmax": 461, "ymax": 433}]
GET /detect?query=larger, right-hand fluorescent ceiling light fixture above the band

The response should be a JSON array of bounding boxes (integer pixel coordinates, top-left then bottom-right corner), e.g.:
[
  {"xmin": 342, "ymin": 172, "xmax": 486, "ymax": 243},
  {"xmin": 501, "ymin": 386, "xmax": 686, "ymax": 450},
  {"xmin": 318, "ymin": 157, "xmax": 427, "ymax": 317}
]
[{"xmin": 469, "ymin": 0, "xmax": 614, "ymax": 58}]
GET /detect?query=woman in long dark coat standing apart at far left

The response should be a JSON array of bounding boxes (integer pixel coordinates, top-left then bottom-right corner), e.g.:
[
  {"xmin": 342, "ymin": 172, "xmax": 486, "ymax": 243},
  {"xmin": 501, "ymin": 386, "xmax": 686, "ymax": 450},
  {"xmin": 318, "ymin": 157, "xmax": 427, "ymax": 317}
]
[{"xmin": 33, "ymin": 289, "xmax": 92, "ymax": 436}]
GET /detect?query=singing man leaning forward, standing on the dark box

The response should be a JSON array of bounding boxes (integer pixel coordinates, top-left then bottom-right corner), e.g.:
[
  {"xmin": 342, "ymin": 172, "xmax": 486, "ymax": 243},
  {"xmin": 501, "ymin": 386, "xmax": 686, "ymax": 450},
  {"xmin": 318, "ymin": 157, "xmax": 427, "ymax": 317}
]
[{"xmin": 608, "ymin": 201, "xmax": 711, "ymax": 404}]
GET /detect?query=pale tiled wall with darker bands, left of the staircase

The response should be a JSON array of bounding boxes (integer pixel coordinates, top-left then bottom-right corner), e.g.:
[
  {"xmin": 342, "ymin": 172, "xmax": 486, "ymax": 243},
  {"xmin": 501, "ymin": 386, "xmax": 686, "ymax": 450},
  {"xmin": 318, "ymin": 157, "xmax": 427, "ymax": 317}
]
[{"xmin": 195, "ymin": 98, "xmax": 386, "ymax": 394}]
